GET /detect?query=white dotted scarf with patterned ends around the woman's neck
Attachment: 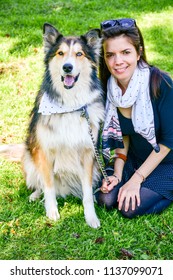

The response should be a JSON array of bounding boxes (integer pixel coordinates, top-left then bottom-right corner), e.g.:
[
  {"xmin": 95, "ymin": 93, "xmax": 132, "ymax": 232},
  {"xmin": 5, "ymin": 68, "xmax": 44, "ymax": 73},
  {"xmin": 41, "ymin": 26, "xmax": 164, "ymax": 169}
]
[{"xmin": 102, "ymin": 66, "xmax": 160, "ymax": 162}]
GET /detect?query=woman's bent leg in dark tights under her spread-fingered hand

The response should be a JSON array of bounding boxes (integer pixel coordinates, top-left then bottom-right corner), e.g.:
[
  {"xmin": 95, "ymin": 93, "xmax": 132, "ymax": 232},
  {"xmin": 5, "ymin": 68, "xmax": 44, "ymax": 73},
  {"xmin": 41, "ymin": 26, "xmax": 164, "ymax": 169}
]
[{"xmin": 121, "ymin": 187, "xmax": 172, "ymax": 218}]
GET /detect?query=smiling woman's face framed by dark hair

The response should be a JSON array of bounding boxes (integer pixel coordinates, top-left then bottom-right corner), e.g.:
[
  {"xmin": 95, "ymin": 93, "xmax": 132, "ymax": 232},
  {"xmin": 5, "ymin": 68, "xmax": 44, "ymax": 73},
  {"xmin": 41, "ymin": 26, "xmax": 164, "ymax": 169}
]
[{"xmin": 103, "ymin": 35, "xmax": 140, "ymax": 88}]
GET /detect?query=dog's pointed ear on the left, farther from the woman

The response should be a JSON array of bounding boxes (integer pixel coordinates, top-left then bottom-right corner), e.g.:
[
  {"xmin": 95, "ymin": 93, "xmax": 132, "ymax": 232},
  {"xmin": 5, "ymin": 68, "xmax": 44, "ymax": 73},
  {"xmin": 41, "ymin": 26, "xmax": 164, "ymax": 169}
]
[{"xmin": 43, "ymin": 23, "xmax": 63, "ymax": 53}]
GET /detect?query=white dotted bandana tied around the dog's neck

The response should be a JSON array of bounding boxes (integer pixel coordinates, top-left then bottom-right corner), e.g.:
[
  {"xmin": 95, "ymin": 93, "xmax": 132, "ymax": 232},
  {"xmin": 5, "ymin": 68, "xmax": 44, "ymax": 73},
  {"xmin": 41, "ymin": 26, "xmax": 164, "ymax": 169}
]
[{"xmin": 38, "ymin": 92, "xmax": 87, "ymax": 116}]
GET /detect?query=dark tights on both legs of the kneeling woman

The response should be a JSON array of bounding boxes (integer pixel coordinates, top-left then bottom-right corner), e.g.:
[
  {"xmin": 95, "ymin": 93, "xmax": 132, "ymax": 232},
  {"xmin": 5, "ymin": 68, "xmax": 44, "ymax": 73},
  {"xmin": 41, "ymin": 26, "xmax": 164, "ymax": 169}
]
[{"xmin": 95, "ymin": 184, "xmax": 172, "ymax": 219}]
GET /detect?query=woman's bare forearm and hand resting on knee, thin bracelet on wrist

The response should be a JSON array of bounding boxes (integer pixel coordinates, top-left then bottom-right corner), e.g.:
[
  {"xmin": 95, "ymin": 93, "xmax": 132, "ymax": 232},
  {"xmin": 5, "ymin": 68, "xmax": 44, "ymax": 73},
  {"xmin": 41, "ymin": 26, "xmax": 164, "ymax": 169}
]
[{"xmin": 118, "ymin": 144, "xmax": 170, "ymax": 211}]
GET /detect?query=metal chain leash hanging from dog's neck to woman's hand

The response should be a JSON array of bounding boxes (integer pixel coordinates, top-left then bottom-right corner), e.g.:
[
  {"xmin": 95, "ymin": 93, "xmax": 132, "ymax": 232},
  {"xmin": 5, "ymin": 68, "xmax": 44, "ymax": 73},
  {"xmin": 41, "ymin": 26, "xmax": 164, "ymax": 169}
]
[{"xmin": 81, "ymin": 105, "xmax": 111, "ymax": 191}]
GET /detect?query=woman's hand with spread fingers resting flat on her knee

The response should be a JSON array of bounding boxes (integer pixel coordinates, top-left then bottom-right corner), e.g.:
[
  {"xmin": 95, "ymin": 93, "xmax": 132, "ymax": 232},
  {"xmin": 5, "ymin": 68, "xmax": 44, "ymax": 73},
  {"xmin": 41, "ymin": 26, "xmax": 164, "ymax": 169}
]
[{"xmin": 117, "ymin": 179, "xmax": 141, "ymax": 212}]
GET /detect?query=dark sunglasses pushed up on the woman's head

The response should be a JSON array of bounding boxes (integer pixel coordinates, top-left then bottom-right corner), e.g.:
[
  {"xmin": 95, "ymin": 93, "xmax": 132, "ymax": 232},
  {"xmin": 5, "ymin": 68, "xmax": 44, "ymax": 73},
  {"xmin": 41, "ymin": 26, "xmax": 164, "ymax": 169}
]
[{"xmin": 100, "ymin": 18, "xmax": 136, "ymax": 30}]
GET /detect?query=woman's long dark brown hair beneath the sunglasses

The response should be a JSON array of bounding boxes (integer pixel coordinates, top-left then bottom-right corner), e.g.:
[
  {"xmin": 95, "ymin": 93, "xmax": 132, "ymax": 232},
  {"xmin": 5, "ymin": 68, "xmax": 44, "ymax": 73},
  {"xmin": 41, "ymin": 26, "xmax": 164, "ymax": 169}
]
[{"xmin": 99, "ymin": 26, "xmax": 167, "ymax": 97}]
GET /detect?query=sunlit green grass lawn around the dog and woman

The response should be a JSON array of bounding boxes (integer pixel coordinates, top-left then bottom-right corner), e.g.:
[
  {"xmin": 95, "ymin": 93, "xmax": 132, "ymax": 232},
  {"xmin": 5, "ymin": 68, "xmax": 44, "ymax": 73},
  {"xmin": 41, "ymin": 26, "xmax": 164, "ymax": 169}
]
[{"xmin": 0, "ymin": 0, "xmax": 173, "ymax": 260}]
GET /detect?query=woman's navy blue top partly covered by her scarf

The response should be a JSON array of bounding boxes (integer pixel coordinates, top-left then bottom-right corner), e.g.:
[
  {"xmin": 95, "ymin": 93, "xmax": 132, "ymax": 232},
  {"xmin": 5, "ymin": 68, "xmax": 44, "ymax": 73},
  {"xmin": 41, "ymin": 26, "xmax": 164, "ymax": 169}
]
[{"xmin": 118, "ymin": 74, "xmax": 173, "ymax": 163}]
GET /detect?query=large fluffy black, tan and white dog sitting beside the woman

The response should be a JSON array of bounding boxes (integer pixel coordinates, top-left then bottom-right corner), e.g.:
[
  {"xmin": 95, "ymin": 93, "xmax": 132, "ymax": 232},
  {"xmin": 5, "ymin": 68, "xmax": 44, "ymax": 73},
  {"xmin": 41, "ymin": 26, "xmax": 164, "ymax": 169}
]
[{"xmin": 23, "ymin": 23, "xmax": 104, "ymax": 228}]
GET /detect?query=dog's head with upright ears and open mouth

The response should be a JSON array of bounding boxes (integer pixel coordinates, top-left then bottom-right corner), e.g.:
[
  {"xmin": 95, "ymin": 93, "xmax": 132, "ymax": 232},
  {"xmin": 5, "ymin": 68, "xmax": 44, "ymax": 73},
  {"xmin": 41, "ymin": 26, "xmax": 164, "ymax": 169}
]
[{"xmin": 43, "ymin": 23, "xmax": 100, "ymax": 89}]
